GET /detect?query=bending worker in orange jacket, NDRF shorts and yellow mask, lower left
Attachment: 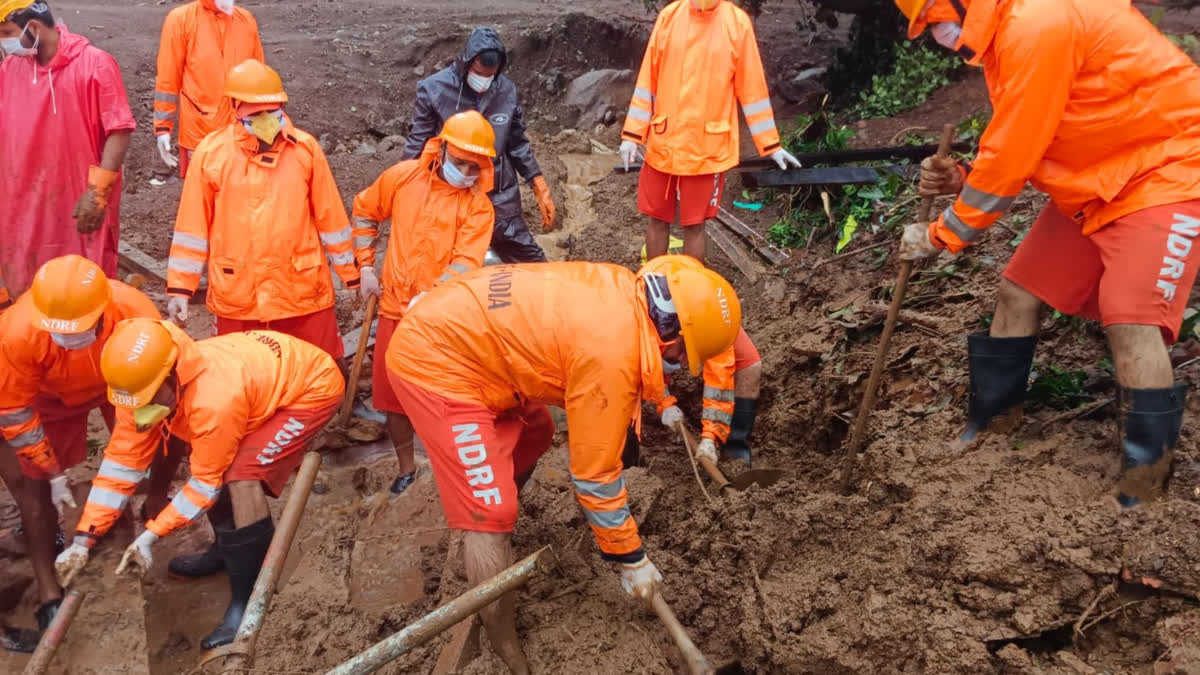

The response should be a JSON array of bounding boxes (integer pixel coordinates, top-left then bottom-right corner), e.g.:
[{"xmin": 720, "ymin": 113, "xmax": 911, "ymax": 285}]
[{"xmin": 56, "ymin": 319, "xmax": 346, "ymax": 650}]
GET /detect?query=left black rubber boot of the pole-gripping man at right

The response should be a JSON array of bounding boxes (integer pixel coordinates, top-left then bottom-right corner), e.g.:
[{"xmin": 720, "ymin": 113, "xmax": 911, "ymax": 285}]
[{"xmin": 959, "ymin": 333, "xmax": 1038, "ymax": 441}]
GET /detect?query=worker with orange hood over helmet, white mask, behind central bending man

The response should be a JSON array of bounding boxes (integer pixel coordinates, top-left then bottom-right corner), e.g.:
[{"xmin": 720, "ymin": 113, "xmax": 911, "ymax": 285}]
[{"xmin": 354, "ymin": 110, "xmax": 496, "ymax": 495}]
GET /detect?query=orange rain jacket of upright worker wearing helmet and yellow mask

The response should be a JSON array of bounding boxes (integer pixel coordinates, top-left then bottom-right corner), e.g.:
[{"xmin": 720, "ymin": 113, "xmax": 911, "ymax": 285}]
[{"xmin": 167, "ymin": 118, "xmax": 359, "ymax": 321}]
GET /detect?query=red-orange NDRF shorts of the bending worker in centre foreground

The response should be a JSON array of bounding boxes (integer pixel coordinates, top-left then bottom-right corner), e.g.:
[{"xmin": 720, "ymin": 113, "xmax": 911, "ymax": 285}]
[{"xmin": 391, "ymin": 375, "xmax": 554, "ymax": 532}]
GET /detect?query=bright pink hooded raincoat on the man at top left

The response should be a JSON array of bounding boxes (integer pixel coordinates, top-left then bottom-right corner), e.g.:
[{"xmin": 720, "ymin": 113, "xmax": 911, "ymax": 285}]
[{"xmin": 0, "ymin": 25, "xmax": 134, "ymax": 297}]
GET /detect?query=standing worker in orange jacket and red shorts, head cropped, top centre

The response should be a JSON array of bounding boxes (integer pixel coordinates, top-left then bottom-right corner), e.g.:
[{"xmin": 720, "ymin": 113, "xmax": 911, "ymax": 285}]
[{"xmin": 620, "ymin": 0, "xmax": 800, "ymax": 261}]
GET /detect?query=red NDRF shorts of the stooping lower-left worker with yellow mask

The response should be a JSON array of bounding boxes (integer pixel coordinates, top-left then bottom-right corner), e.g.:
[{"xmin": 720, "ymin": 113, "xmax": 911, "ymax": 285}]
[{"xmin": 224, "ymin": 400, "xmax": 342, "ymax": 497}]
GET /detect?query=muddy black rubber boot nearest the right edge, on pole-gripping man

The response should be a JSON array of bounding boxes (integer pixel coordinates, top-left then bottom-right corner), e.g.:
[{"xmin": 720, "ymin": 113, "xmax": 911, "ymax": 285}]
[{"xmin": 1117, "ymin": 384, "xmax": 1188, "ymax": 508}]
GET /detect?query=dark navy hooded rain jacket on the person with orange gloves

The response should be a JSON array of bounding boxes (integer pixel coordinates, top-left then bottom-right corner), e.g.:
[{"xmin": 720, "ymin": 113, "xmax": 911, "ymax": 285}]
[{"xmin": 403, "ymin": 28, "xmax": 541, "ymax": 223}]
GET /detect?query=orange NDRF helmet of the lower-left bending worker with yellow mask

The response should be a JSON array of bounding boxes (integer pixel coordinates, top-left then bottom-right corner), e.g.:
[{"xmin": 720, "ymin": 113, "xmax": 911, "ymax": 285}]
[{"xmin": 100, "ymin": 318, "xmax": 179, "ymax": 408}]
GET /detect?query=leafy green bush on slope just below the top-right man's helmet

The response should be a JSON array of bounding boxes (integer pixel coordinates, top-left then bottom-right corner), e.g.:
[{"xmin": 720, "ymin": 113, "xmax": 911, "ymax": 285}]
[{"xmin": 854, "ymin": 41, "xmax": 962, "ymax": 118}]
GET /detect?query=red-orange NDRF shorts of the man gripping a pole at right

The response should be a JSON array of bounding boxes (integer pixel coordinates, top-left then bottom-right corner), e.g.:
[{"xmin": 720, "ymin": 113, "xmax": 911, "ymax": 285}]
[{"xmin": 1004, "ymin": 199, "xmax": 1200, "ymax": 342}]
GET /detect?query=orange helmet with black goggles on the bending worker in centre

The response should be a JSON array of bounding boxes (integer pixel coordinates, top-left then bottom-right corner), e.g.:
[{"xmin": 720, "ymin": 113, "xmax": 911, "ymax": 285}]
[{"xmin": 640, "ymin": 256, "xmax": 742, "ymax": 375}]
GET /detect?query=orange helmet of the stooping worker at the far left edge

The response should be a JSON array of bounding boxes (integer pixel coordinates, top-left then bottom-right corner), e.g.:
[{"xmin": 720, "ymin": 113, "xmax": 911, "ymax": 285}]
[{"xmin": 29, "ymin": 255, "xmax": 113, "ymax": 334}]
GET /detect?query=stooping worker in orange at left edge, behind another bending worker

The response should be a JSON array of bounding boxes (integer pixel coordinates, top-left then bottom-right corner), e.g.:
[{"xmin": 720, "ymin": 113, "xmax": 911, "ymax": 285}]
[{"xmin": 0, "ymin": 255, "xmax": 160, "ymax": 631}]
